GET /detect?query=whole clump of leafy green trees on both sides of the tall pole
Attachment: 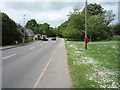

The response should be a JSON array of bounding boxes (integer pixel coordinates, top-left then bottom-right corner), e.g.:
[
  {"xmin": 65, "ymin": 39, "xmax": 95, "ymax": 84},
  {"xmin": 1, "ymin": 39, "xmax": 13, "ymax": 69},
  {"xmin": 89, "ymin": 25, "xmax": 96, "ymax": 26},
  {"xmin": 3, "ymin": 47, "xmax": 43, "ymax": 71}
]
[{"xmin": 58, "ymin": 3, "xmax": 115, "ymax": 41}]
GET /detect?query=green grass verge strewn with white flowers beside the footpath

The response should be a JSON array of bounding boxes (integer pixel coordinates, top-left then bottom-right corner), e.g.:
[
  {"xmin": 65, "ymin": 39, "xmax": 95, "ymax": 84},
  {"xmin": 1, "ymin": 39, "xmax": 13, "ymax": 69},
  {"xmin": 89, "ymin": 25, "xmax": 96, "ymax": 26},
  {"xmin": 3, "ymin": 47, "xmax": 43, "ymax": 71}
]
[{"xmin": 66, "ymin": 41, "xmax": 119, "ymax": 88}]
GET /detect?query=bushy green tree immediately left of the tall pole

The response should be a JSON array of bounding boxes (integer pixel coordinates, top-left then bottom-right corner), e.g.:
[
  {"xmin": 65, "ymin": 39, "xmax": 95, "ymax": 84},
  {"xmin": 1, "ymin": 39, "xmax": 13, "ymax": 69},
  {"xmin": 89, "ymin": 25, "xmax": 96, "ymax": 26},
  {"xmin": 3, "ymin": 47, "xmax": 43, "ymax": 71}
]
[{"xmin": 62, "ymin": 11, "xmax": 84, "ymax": 40}]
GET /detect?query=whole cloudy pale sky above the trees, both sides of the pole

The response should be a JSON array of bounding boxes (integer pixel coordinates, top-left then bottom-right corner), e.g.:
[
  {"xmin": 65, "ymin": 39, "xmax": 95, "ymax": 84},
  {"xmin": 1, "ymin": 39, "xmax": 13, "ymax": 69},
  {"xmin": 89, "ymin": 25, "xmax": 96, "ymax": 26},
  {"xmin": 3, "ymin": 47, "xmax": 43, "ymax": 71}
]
[{"xmin": 0, "ymin": 0, "xmax": 119, "ymax": 27}]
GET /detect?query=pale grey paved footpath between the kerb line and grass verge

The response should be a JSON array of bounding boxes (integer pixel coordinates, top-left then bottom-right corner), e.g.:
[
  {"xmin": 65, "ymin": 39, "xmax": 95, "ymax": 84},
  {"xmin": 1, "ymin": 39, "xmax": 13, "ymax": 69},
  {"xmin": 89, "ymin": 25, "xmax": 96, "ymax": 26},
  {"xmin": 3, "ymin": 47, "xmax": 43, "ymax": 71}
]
[{"xmin": 36, "ymin": 39, "xmax": 71, "ymax": 88}]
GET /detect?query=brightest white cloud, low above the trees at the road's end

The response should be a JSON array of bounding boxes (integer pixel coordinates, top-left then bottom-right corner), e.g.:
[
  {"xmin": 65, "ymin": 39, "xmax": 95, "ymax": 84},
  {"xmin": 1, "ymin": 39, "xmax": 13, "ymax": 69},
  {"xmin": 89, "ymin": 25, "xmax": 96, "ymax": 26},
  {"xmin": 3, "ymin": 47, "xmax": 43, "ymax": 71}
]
[{"xmin": 28, "ymin": 7, "xmax": 72, "ymax": 27}]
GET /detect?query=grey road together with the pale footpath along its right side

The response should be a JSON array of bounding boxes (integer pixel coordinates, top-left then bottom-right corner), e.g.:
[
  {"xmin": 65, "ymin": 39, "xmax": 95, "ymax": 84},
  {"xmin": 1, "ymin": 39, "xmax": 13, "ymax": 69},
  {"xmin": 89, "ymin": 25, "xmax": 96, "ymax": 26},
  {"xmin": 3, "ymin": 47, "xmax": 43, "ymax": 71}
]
[{"xmin": 2, "ymin": 39, "xmax": 71, "ymax": 88}]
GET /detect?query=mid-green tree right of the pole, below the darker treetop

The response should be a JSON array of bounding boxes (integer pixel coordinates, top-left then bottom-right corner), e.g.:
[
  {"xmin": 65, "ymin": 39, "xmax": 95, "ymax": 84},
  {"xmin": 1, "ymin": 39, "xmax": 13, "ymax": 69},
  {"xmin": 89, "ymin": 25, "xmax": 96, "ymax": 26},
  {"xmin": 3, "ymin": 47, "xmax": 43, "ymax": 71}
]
[{"xmin": 88, "ymin": 15, "xmax": 110, "ymax": 41}]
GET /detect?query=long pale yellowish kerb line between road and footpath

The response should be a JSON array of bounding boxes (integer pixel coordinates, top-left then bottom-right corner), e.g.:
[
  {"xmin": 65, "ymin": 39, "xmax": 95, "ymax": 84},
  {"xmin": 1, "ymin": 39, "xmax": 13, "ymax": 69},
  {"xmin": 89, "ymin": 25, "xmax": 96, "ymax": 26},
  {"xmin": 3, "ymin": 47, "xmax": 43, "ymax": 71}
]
[{"xmin": 33, "ymin": 44, "xmax": 57, "ymax": 88}]
